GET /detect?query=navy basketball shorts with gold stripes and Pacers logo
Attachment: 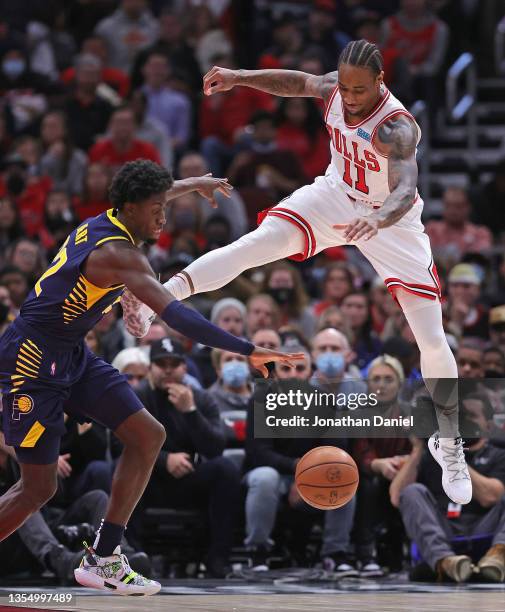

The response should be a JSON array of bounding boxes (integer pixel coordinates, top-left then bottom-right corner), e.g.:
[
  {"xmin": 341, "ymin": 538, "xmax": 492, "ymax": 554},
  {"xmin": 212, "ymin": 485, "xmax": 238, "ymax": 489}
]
[{"xmin": 0, "ymin": 318, "xmax": 143, "ymax": 464}]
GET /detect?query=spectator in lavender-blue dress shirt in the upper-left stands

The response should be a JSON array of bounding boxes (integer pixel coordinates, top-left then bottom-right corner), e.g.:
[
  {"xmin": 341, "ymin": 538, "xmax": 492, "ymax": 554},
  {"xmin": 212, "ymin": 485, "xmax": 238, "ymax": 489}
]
[{"xmin": 142, "ymin": 52, "xmax": 191, "ymax": 151}]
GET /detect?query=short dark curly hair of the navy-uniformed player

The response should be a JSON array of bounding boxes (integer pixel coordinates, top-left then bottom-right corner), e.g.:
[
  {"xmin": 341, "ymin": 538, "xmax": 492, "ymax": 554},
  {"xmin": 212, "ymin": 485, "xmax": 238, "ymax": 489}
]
[{"xmin": 109, "ymin": 159, "xmax": 174, "ymax": 210}]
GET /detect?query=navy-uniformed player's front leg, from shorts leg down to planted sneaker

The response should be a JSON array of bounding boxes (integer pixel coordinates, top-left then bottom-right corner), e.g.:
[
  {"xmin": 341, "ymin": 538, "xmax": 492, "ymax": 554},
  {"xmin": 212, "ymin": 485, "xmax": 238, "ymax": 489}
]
[{"xmin": 65, "ymin": 352, "xmax": 165, "ymax": 595}]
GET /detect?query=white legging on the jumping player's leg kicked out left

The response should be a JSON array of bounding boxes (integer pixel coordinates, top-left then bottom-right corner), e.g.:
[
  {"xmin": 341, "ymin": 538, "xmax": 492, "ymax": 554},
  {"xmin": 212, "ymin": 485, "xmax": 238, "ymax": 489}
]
[{"xmin": 165, "ymin": 217, "xmax": 304, "ymax": 300}]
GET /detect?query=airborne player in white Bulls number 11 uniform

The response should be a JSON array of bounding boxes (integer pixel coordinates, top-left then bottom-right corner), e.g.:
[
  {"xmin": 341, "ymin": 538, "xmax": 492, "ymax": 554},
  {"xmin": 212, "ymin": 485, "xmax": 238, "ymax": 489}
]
[{"xmin": 124, "ymin": 40, "xmax": 472, "ymax": 504}]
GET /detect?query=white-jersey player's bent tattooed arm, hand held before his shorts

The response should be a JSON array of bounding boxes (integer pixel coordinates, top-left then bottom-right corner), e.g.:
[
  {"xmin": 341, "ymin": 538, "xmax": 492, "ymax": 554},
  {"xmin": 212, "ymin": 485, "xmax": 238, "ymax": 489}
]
[{"xmin": 333, "ymin": 115, "xmax": 417, "ymax": 242}]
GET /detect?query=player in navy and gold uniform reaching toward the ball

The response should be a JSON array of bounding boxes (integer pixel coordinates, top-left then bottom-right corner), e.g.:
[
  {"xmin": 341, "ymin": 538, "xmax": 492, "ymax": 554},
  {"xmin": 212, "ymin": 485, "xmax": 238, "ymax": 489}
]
[{"xmin": 0, "ymin": 160, "xmax": 301, "ymax": 595}]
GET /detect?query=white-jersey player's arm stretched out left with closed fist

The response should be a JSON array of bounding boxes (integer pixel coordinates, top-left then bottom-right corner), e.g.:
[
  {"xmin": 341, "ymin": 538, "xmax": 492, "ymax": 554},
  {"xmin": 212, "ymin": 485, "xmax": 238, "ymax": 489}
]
[{"xmin": 203, "ymin": 66, "xmax": 338, "ymax": 100}]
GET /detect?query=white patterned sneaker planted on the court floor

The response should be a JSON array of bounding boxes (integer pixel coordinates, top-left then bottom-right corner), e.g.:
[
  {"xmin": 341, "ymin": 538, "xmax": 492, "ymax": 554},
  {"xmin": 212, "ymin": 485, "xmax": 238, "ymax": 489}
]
[{"xmin": 74, "ymin": 542, "xmax": 161, "ymax": 595}]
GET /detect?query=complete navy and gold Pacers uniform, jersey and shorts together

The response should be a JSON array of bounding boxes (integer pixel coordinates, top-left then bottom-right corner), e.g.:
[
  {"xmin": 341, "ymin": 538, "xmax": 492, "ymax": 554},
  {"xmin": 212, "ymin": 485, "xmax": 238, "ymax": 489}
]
[{"xmin": 0, "ymin": 210, "xmax": 143, "ymax": 463}]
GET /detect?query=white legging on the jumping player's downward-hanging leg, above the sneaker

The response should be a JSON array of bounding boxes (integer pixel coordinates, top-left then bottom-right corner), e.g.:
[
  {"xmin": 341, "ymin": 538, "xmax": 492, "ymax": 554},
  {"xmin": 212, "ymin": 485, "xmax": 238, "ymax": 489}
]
[{"xmin": 397, "ymin": 290, "xmax": 459, "ymax": 439}]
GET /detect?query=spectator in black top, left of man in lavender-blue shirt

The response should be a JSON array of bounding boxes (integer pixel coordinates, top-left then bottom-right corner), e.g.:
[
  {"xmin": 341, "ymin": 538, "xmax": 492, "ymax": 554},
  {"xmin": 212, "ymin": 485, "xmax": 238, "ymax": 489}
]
[{"xmin": 64, "ymin": 53, "xmax": 114, "ymax": 151}]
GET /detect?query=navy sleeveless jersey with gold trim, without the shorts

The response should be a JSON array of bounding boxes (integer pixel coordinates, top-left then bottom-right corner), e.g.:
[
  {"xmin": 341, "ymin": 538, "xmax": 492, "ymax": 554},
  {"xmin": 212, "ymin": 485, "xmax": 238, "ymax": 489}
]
[{"xmin": 20, "ymin": 209, "xmax": 134, "ymax": 347}]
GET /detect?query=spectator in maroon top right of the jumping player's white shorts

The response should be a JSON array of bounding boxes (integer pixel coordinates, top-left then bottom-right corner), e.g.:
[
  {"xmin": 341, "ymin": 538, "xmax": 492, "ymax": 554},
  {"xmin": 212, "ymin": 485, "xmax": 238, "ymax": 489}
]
[{"xmin": 426, "ymin": 187, "xmax": 493, "ymax": 263}]
